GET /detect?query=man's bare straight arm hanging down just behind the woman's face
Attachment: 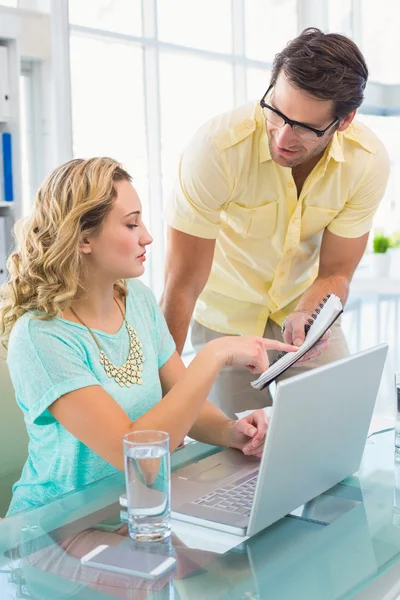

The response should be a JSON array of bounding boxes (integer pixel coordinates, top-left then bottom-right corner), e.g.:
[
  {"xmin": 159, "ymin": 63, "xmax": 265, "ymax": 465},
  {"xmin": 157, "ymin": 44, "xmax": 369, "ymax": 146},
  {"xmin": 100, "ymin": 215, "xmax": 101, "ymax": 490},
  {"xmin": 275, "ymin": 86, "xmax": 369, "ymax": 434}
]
[{"xmin": 160, "ymin": 227, "xmax": 215, "ymax": 354}]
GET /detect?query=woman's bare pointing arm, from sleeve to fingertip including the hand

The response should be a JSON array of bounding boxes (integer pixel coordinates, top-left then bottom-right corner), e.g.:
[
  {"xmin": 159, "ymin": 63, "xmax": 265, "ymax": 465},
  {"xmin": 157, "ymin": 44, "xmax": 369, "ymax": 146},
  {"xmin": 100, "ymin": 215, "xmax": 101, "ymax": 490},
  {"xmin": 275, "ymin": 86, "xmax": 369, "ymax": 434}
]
[{"xmin": 49, "ymin": 337, "xmax": 294, "ymax": 470}]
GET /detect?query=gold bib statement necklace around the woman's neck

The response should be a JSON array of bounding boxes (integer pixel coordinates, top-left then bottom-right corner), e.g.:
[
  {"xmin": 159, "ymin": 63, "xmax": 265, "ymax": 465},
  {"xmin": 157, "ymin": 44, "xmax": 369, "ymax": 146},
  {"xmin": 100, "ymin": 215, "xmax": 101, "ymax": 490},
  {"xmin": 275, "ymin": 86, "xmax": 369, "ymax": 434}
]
[{"xmin": 70, "ymin": 298, "xmax": 144, "ymax": 387}]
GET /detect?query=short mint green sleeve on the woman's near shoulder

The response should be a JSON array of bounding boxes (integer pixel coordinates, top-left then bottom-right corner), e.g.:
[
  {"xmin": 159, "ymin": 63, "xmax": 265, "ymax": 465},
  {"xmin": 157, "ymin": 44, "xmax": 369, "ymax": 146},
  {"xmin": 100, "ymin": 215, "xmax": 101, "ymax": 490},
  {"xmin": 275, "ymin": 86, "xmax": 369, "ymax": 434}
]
[{"xmin": 7, "ymin": 317, "xmax": 100, "ymax": 424}]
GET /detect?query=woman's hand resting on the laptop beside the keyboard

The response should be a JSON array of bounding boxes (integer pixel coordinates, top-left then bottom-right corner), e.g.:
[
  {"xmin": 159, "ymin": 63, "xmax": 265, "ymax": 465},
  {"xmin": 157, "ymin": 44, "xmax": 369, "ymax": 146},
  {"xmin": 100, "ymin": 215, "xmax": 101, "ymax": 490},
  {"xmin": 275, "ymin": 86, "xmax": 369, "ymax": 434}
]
[{"xmin": 229, "ymin": 410, "xmax": 268, "ymax": 456}]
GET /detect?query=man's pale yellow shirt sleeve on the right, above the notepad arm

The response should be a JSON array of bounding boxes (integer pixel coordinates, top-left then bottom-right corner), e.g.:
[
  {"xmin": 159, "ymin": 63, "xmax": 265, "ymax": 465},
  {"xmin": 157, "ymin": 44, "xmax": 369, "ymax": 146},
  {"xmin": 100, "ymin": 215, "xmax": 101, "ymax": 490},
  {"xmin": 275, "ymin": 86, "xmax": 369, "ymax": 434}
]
[{"xmin": 328, "ymin": 145, "xmax": 390, "ymax": 238}]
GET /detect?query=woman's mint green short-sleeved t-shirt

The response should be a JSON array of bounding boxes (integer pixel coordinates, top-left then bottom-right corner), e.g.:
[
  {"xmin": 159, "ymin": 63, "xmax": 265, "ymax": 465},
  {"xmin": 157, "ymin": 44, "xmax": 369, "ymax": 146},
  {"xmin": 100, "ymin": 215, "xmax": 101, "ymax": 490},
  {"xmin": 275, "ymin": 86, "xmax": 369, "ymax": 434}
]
[{"xmin": 7, "ymin": 279, "xmax": 175, "ymax": 514}]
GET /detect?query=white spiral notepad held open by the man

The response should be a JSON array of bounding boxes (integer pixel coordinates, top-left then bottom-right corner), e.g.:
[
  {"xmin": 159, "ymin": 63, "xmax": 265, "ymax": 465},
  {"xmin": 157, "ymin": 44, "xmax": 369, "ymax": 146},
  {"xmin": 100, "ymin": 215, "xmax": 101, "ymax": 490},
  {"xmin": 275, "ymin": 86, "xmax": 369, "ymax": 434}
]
[{"xmin": 251, "ymin": 294, "xmax": 343, "ymax": 390}]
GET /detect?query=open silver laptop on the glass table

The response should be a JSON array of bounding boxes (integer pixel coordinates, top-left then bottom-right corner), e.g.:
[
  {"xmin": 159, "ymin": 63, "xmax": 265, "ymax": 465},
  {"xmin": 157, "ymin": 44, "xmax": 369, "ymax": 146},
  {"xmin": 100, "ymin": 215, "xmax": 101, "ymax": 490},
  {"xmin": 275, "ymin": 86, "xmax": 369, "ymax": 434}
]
[{"xmin": 172, "ymin": 344, "xmax": 388, "ymax": 536}]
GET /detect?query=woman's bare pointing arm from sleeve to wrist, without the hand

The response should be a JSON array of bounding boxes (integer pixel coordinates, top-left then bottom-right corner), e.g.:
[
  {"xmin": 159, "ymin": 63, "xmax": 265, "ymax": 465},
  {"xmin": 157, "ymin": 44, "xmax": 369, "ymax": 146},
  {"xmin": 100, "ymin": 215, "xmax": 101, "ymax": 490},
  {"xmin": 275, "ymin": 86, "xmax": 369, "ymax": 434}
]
[{"xmin": 49, "ymin": 346, "xmax": 223, "ymax": 470}]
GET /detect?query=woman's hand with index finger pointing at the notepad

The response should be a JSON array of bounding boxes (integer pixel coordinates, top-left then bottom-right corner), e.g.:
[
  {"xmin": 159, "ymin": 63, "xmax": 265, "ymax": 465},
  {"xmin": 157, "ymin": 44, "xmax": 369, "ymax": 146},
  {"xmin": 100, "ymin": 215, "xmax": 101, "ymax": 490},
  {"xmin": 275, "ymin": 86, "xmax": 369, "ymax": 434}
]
[{"xmin": 207, "ymin": 336, "xmax": 298, "ymax": 373}]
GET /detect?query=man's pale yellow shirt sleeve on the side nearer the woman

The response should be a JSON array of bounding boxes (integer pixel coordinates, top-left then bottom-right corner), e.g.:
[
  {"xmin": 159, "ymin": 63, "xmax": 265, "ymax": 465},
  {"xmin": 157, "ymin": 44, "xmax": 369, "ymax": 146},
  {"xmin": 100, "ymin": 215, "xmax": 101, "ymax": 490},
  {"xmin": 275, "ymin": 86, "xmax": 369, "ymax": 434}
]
[{"xmin": 165, "ymin": 124, "xmax": 232, "ymax": 239}]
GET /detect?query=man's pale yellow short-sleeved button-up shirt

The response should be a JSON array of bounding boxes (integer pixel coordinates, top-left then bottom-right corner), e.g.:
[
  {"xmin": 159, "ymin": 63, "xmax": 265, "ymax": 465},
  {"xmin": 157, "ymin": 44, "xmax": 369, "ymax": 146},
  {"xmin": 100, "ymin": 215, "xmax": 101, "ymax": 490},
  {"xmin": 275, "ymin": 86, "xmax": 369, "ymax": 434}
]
[{"xmin": 166, "ymin": 103, "xmax": 389, "ymax": 335}]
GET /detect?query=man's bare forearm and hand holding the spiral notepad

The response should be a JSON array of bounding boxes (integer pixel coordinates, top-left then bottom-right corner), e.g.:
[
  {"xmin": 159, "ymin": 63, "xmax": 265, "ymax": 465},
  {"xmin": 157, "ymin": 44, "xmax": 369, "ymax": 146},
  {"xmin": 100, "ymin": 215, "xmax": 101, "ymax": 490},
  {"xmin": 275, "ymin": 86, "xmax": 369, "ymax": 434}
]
[{"xmin": 284, "ymin": 229, "xmax": 369, "ymax": 346}]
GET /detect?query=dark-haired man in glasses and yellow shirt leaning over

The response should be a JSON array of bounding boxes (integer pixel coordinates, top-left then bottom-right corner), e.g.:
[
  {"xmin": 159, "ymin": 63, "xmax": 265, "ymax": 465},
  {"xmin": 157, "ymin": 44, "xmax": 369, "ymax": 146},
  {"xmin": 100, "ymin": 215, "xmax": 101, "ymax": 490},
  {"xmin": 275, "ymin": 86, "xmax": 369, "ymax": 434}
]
[{"xmin": 161, "ymin": 28, "xmax": 389, "ymax": 416}]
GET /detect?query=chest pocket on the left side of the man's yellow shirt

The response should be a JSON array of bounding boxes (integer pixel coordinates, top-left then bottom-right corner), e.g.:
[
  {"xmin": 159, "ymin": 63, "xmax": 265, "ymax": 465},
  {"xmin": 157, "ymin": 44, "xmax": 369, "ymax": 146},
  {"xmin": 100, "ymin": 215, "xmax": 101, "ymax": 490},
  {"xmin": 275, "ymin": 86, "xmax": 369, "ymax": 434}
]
[{"xmin": 226, "ymin": 202, "xmax": 277, "ymax": 239}]
